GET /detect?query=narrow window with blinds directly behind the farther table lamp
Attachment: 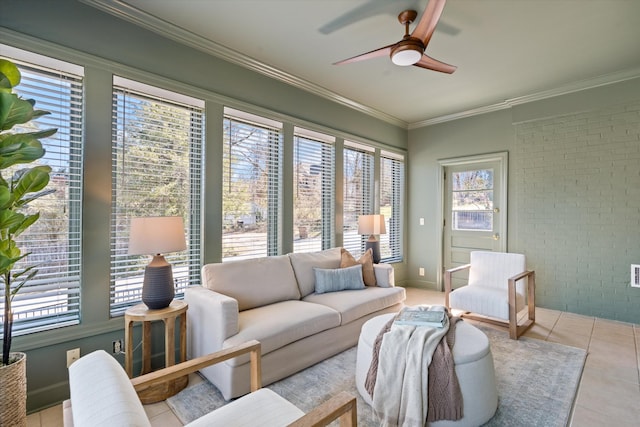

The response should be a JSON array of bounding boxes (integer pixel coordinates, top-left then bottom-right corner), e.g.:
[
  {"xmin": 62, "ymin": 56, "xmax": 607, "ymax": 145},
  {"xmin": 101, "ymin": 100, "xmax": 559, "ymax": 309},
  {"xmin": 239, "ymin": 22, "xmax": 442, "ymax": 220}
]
[{"xmin": 342, "ymin": 141, "xmax": 374, "ymax": 256}]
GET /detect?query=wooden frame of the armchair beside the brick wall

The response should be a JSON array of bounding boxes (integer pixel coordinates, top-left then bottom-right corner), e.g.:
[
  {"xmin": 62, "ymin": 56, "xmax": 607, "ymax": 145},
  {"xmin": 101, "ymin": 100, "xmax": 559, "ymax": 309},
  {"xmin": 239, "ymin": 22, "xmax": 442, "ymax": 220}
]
[{"xmin": 444, "ymin": 264, "xmax": 536, "ymax": 340}]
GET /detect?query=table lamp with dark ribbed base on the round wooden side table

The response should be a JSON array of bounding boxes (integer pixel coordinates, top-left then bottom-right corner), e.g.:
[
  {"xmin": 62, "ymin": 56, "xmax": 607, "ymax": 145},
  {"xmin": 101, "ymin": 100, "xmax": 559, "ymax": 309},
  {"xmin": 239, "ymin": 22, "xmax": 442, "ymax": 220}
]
[{"xmin": 129, "ymin": 216, "xmax": 187, "ymax": 310}]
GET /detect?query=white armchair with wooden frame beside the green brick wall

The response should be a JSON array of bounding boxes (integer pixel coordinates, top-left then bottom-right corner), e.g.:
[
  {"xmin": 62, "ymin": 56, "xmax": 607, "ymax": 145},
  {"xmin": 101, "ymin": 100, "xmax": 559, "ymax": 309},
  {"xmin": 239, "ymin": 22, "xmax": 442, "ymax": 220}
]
[{"xmin": 444, "ymin": 251, "xmax": 536, "ymax": 339}]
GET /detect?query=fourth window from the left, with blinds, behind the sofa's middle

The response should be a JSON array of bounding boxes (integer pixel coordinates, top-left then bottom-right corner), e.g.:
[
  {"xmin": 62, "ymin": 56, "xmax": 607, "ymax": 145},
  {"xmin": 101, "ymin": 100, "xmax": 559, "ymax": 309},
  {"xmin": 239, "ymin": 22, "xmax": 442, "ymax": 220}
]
[{"xmin": 293, "ymin": 128, "xmax": 335, "ymax": 252}]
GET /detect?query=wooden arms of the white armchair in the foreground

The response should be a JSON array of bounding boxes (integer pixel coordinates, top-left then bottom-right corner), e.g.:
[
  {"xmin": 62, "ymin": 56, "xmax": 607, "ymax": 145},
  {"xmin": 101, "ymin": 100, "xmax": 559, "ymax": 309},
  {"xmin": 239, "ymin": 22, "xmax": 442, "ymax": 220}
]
[{"xmin": 131, "ymin": 340, "xmax": 358, "ymax": 427}]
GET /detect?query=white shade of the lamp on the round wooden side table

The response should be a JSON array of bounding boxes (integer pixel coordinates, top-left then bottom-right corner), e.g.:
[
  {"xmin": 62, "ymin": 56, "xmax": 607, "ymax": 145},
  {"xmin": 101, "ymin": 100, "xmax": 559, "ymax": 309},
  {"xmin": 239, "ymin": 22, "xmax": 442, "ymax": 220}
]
[{"xmin": 129, "ymin": 216, "xmax": 187, "ymax": 255}]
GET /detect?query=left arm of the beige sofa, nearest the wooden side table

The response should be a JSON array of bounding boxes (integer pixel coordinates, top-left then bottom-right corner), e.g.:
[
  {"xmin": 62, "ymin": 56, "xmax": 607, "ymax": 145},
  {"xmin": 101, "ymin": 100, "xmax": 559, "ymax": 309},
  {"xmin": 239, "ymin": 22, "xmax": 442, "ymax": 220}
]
[{"xmin": 184, "ymin": 286, "xmax": 239, "ymax": 359}]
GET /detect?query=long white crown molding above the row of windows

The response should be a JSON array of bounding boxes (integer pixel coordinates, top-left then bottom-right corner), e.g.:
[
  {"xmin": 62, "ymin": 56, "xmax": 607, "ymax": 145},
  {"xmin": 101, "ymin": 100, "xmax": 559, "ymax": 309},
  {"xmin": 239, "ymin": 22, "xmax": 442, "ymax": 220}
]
[{"xmin": 80, "ymin": 0, "xmax": 408, "ymax": 129}]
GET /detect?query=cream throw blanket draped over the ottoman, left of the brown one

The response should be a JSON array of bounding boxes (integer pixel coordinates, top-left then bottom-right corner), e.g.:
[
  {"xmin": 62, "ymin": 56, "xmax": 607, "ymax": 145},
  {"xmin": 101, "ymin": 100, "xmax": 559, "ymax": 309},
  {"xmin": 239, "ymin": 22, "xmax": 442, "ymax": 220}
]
[{"xmin": 373, "ymin": 307, "xmax": 449, "ymax": 427}]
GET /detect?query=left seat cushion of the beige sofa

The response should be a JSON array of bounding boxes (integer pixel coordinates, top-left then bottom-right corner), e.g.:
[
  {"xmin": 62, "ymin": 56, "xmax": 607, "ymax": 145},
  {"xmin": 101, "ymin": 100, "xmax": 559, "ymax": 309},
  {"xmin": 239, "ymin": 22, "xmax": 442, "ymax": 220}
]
[{"xmin": 224, "ymin": 300, "xmax": 340, "ymax": 366}]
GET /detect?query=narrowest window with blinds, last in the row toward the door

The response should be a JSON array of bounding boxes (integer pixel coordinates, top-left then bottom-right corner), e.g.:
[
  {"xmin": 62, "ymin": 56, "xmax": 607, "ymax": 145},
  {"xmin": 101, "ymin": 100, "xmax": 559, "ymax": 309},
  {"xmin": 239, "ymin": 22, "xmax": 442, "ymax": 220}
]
[{"xmin": 380, "ymin": 151, "xmax": 404, "ymax": 262}]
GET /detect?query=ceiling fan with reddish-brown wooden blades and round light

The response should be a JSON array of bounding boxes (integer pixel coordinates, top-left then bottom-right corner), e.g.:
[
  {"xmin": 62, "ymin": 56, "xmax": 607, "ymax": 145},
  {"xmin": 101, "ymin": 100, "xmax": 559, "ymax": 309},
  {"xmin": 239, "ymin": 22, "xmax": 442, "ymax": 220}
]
[{"xmin": 334, "ymin": 0, "xmax": 457, "ymax": 74}]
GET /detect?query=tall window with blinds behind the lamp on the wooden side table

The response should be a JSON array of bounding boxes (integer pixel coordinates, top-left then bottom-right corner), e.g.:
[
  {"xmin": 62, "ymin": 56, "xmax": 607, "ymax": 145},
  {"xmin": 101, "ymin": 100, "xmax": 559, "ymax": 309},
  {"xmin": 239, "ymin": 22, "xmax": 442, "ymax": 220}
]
[{"xmin": 110, "ymin": 77, "xmax": 204, "ymax": 316}]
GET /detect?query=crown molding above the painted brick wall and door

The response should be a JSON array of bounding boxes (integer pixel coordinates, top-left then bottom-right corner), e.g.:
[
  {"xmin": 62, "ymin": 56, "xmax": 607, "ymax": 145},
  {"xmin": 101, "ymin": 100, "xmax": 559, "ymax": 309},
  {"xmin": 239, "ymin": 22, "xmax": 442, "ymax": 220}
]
[{"xmin": 407, "ymin": 68, "xmax": 640, "ymax": 130}]
